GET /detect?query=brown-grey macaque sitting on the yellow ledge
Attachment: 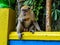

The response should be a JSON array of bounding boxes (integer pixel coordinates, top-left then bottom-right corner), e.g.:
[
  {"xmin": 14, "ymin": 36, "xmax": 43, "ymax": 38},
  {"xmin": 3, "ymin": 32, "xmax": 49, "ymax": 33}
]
[{"xmin": 16, "ymin": 6, "xmax": 41, "ymax": 38}]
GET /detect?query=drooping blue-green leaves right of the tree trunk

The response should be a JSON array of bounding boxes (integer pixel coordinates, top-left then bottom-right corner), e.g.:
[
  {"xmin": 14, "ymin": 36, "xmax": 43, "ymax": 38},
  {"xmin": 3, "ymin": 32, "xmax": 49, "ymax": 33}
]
[{"xmin": 52, "ymin": 0, "xmax": 60, "ymax": 21}]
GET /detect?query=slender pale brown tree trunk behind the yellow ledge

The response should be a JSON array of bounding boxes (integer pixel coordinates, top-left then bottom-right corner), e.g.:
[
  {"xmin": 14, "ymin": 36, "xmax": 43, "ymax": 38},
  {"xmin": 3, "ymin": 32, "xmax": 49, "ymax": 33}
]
[{"xmin": 46, "ymin": 0, "xmax": 52, "ymax": 31}]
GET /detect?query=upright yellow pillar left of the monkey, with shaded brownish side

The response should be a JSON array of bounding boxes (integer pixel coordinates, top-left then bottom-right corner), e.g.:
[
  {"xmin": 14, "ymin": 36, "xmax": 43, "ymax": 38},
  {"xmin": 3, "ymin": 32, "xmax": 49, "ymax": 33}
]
[{"xmin": 0, "ymin": 8, "xmax": 15, "ymax": 45}]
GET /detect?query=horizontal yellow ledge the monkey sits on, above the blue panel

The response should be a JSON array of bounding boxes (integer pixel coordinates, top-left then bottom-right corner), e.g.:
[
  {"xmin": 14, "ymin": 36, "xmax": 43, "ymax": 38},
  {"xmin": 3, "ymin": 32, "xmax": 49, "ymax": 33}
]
[{"xmin": 9, "ymin": 32, "xmax": 60, "ymax": 40}]
